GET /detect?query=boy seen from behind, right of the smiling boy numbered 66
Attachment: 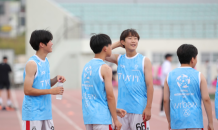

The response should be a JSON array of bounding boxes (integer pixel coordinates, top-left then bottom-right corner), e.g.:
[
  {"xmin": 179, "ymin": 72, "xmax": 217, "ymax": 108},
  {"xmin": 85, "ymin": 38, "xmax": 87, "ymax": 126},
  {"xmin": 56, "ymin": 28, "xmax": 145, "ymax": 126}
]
[{"xmin": 164, "ymin": 44, "xmax": 214, "ymax": 130}]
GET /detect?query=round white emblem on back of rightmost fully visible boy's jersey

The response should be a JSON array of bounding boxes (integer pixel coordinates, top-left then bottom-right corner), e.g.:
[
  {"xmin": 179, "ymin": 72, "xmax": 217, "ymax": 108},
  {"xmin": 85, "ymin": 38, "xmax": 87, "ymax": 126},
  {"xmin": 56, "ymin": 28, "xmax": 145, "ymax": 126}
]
[{"xmin": 176, "ymin": 74, "xmax": 190, "ymax": 88}]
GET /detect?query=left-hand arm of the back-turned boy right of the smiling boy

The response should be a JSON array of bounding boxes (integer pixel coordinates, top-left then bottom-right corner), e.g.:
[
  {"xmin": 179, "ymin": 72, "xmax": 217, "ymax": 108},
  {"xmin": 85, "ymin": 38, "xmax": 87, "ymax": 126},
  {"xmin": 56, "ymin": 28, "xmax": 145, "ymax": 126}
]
[{"xmin": 164, "ymin": 77, "xmax": 170, "ymax": 130}]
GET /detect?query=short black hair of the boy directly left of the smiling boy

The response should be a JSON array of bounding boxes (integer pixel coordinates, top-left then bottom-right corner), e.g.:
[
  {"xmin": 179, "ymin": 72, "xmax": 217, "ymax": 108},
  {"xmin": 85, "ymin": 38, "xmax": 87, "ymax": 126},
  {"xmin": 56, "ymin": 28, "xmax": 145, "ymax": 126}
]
[{"xmin": 90, "ymin": 34, "xmax": 112, "ymax": 54}]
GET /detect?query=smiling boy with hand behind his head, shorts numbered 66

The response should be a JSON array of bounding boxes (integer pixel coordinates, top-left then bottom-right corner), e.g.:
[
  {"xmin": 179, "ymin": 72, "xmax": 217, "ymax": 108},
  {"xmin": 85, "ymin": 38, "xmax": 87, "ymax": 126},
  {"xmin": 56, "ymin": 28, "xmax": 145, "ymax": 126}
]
[{"xmin": 106, "ymin": 29, "xmax": 153, "ymax": 130}]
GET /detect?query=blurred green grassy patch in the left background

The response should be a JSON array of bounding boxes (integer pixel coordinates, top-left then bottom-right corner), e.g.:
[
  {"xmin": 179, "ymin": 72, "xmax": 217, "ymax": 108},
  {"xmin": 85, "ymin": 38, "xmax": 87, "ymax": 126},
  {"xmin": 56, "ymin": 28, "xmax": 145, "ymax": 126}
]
[{"xmin": 0, "ymin": 34, "xmax": 25, "ymax": 55}]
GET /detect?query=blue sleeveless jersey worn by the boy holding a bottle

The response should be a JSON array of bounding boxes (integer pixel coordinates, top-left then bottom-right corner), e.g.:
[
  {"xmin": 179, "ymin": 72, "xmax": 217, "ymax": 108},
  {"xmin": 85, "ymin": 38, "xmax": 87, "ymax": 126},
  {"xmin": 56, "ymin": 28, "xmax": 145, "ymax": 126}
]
[{"xmin": 22, "ymin": 55, "xmax": 52, "ymax": 121}]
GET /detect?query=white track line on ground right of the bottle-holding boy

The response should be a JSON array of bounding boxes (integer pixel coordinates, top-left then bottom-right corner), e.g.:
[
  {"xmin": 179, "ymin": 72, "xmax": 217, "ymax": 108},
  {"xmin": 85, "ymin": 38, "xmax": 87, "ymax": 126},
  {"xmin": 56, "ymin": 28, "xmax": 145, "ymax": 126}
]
[{"xmin": 52, "ymin": 105, "xmax": 83, "ymax": 130}]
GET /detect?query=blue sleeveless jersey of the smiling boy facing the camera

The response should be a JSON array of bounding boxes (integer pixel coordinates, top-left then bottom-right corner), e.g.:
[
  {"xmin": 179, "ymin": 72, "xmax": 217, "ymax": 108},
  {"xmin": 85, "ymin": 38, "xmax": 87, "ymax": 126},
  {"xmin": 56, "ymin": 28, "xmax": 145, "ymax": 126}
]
[{"xmin": 117, "ymin": 53, "xmax": 147, "ymax": 114}]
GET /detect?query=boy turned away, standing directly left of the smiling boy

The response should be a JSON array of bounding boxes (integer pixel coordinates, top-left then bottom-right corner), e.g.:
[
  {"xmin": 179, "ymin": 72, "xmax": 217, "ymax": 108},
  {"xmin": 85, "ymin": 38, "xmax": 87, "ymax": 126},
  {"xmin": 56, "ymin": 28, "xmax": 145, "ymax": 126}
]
[{"xmin": 81, "ymin": 34, "xmax": 125, "ymax": 130}]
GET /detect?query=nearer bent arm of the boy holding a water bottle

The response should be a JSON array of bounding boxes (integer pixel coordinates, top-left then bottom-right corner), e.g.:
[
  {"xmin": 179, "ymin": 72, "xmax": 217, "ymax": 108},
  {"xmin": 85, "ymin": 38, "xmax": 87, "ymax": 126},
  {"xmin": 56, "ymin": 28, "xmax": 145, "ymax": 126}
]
[{"xmin": 24, "ymin": 61, "xmax": 63, "ymax": 96}]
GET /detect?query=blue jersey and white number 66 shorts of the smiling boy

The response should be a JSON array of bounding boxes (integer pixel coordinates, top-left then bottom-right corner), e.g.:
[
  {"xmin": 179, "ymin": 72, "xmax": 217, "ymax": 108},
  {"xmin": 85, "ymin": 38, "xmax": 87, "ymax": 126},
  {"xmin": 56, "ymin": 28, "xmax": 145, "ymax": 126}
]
[{"xmin": 117, "ymin": 53, "xmax": 150, "ymax": 130}]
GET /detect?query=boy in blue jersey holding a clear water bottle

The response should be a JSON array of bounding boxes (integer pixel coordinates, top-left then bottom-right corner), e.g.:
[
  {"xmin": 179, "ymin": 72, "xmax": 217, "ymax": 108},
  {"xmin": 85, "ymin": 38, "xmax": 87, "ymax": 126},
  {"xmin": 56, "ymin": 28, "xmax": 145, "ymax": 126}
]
[{"xmin": 22, "ymin": 30, "xmax": 66, "ymax": 130}]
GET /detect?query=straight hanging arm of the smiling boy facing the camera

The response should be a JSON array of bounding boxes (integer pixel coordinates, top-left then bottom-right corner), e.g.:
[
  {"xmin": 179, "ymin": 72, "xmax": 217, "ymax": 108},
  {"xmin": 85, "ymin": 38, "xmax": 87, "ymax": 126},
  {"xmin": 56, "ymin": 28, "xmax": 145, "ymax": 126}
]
[{"xmin": 142, "ymin": 57, "xmax": 154, "ymax": 121}]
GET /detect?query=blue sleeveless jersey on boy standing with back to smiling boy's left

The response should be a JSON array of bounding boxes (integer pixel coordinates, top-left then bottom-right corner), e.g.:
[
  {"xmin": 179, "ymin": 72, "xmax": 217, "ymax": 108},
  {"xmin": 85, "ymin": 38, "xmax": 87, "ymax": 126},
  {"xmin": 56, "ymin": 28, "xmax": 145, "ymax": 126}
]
[{"xmin": 81, "ymin": 58, "xmax": 112, "ymax": 124}]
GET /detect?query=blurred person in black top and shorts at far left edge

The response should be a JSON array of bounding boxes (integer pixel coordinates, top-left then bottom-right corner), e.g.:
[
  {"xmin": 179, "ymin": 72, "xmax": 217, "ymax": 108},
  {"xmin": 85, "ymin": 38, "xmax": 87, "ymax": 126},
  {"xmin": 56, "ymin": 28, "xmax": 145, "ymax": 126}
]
[{"xmin": 0, "ymin": 56, "xmax": 11, "ymax": 109}]
